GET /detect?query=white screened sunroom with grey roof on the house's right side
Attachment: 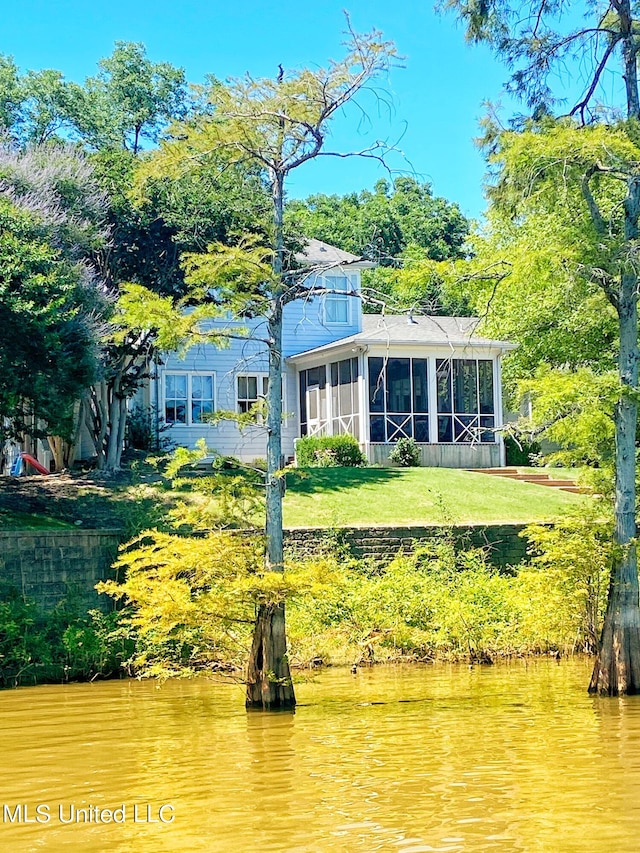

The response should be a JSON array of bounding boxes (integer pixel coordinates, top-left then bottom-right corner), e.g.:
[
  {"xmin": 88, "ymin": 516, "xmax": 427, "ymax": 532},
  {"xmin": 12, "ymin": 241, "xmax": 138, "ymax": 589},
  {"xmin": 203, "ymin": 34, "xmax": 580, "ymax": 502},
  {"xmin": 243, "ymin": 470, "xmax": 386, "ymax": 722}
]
[{"xmin": 288, "ymin": 315, "xmax": 513, "ymax": 468}]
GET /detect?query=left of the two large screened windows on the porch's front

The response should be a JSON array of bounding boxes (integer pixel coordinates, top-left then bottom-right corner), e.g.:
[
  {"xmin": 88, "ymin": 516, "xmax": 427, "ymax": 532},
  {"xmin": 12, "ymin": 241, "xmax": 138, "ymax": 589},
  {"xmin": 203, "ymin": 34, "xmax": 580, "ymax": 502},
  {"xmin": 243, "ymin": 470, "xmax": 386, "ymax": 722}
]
[{"xmin": 369, "ymin": 357, "xmax": 429, "ymax": 443}]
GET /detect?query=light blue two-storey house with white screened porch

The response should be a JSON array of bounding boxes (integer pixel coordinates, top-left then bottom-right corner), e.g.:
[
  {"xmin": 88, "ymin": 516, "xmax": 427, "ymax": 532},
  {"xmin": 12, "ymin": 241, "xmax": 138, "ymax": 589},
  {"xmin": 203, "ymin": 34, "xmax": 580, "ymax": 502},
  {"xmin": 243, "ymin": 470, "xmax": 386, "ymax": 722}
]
[{"xmin": 147, "ymin": 240, "xmax": 514, "ymax": 468}]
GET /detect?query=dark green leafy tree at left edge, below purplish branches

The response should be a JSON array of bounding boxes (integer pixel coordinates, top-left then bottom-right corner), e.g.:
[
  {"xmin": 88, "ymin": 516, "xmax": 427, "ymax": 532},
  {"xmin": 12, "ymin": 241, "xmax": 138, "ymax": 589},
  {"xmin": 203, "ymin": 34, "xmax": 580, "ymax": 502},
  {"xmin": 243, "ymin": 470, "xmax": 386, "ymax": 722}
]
[{"xmin": 0, "ymin": 196, "xmax": 96, "ymax": 436}]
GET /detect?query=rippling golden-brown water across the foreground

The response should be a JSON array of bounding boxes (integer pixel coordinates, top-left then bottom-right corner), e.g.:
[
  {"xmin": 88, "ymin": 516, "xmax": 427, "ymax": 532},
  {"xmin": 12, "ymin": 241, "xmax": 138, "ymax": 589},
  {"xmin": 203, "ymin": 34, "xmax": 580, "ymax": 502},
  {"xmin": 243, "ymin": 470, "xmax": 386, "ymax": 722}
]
[{"xmin": 0, "ymin": 661, "xmax": 640, "ymax": 853}]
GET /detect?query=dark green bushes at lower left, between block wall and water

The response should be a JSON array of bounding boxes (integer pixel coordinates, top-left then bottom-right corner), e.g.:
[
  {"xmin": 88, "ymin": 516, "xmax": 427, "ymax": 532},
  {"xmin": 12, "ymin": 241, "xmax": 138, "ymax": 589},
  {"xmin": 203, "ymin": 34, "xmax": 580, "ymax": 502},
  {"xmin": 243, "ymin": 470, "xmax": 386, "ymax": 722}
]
[{"xmin": 0, "ymin": 586, "xmax": 132, "ymax": 687}]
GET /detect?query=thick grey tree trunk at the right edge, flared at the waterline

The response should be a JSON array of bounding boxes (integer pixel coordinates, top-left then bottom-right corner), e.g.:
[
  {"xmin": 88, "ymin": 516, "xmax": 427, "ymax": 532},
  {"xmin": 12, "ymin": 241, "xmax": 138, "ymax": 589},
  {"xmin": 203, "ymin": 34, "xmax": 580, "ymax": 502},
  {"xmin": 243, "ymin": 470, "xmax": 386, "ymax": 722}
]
[{"xmin": 589, "ymin": 180, "xmax": 640, "ymax": 696}]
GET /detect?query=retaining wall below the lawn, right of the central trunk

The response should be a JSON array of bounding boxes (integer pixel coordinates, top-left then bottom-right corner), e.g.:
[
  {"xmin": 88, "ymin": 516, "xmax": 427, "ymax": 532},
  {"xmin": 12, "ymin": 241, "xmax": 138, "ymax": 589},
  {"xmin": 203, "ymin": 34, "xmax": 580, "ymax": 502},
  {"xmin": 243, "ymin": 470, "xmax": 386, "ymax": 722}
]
[{"xmin": 285, "ymin": 524, "xmax": 527, "ymax": 568}]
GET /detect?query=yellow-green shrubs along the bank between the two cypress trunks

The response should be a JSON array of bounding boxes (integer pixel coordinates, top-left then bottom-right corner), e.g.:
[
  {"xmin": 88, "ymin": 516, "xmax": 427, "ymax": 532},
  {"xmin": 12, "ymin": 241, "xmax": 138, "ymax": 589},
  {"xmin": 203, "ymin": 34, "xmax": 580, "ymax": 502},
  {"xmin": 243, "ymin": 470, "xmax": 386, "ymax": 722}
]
[{"xmin": 288, "ymin": 514, "xmax": 612, "ymax": 663}]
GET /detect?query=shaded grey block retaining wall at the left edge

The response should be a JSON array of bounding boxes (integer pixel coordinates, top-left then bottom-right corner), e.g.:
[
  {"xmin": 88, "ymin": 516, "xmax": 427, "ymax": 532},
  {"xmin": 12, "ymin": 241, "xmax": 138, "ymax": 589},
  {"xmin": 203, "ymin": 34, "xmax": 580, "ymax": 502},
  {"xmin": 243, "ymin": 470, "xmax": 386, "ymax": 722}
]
[{"xmin": 0, "ymin": 530, "xmax": 121, "ymax": 612}]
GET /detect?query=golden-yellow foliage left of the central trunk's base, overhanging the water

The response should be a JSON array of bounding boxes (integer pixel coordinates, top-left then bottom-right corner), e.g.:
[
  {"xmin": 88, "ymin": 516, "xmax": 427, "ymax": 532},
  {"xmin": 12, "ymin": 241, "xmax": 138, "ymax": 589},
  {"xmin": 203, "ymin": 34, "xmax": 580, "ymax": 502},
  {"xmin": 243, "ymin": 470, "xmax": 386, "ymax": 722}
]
[{"xmin": 98, "ymin": 531, "xmax": 336, "ymax": 677}]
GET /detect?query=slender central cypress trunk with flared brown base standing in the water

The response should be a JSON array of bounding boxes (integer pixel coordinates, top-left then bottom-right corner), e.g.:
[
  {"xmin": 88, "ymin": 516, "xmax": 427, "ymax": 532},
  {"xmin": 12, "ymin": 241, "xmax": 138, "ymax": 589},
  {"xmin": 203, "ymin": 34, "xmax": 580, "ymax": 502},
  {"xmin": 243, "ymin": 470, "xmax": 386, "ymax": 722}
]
[{"xmin": 246, "ymin": 166, "xmax": 296, "ymax": 711}]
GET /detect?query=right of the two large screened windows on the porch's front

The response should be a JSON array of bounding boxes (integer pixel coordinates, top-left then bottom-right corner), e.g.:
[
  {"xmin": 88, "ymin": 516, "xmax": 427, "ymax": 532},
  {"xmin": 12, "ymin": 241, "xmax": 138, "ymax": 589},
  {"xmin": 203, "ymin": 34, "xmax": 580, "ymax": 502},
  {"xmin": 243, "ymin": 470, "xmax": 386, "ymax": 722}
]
[{"xmin": 436, "ymin": 358, "xmax": 495, "ymax": 443}]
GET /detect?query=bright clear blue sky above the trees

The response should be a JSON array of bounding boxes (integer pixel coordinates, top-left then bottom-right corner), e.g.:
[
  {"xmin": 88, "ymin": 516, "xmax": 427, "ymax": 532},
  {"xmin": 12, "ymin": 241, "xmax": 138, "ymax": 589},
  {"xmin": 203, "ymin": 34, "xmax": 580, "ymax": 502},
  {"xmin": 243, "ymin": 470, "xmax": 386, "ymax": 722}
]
[{"xmin": 6, "ymin": 0, "xmax": 520, "ymax": 217}]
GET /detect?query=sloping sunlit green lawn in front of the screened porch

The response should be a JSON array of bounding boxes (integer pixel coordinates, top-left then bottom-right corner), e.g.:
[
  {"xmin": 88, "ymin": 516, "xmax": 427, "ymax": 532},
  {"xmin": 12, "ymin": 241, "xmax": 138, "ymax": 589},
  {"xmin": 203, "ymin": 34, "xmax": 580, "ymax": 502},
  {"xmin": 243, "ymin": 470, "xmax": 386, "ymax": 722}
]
[{"xmin": 284, "ymin": 468, "xmax": 589, "ymax": 527}]
